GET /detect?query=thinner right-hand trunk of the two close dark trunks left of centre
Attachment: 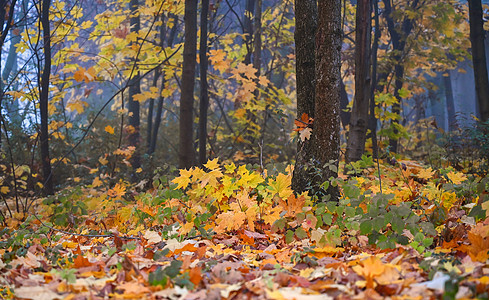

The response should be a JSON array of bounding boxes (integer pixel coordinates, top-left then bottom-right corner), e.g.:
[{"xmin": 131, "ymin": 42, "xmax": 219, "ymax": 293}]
[{"xmin": 199, "ymin": 0, "xmax": 209, "ymax": 165}]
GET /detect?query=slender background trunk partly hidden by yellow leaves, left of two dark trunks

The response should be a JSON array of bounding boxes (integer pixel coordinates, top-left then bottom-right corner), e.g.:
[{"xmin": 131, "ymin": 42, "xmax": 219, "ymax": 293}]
[{"xmin": 128, "ymin": 0, "xmax": 141, "ymax": 173}]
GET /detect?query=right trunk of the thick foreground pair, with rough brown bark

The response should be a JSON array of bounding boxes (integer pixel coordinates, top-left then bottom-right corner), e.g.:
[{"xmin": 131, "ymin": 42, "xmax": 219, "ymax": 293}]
[{"xmin": 311, "ymin": 0, "xmax": 342, "ymax": 201}]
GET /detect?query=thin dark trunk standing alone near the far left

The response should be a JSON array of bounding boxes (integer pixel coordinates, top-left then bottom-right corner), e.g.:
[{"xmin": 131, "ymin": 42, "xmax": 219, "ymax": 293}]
[{"xmin": 39, "ymin": 0, "xmax": 54, "ymax": 195}]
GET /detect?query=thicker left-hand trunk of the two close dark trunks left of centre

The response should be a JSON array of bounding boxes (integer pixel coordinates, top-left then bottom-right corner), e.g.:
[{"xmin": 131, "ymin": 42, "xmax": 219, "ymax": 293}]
[{"xmin": 179, "ymin": 0, "xmax": 197, "ymax": 169}]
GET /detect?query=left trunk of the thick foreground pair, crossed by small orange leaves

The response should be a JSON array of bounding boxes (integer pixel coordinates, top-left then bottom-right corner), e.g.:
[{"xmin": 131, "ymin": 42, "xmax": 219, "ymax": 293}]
[{"xmin": 292, "ymin": 0, "xmax": 318, "ymax": 193}]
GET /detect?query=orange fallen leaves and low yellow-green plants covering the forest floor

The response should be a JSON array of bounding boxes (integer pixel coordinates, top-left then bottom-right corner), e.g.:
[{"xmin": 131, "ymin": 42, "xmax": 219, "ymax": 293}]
[{"xmin": 0, "ymin": 158, "xmax": 489, "ymax": 299}]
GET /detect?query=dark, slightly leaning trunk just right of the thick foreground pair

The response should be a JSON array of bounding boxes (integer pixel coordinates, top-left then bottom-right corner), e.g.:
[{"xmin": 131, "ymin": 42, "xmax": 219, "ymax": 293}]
[{"xmin": 346, "ymin": 0, "xmax": 372, "ymax": 163}]
